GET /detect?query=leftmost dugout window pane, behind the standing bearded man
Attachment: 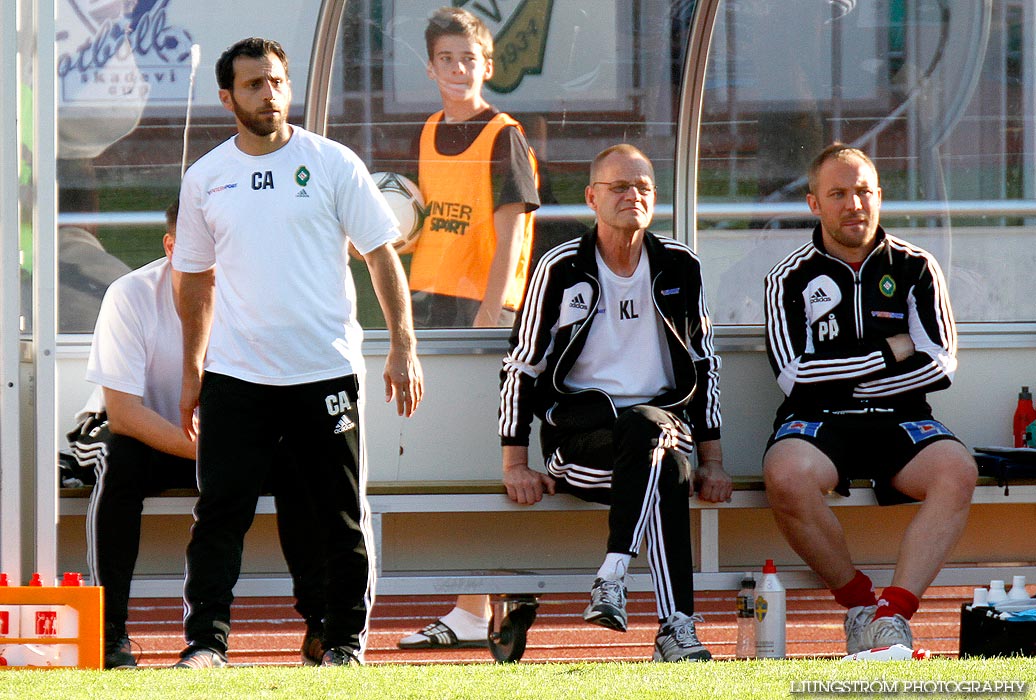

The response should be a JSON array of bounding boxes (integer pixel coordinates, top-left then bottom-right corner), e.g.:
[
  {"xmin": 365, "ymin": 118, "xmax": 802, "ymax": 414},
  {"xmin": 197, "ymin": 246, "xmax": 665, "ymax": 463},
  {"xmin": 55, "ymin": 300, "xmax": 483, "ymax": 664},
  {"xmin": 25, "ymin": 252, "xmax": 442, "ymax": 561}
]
[{"xmin": 42, "ymin": 0, "xmax": 320, "ymax": 332}]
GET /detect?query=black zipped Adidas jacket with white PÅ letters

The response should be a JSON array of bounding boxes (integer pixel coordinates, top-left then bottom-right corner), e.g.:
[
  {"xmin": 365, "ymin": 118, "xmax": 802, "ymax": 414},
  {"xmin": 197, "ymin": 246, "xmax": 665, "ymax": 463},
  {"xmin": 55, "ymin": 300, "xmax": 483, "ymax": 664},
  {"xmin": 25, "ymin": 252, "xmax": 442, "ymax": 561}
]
[{"xmin": 766, "ymin": 226, "xmax": 957, "ymax": 421}]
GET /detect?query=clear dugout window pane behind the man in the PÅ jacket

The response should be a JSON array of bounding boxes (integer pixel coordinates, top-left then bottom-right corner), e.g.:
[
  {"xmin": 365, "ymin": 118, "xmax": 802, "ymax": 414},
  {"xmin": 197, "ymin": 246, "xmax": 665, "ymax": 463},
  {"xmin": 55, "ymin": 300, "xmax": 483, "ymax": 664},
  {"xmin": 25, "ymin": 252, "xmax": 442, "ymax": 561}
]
[{"xmin": 697, "ymin": 0, "xmax": 1036, "ymax": 323}]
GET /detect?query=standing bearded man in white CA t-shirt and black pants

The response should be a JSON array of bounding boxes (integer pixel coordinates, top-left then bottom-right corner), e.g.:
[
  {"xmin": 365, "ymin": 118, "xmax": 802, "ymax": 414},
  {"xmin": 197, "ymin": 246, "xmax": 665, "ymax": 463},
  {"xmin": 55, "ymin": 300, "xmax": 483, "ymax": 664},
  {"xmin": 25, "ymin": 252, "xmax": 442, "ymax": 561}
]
[{"xmin": 173, "ymin": 37, "xmax": 424, "ymax": 668}]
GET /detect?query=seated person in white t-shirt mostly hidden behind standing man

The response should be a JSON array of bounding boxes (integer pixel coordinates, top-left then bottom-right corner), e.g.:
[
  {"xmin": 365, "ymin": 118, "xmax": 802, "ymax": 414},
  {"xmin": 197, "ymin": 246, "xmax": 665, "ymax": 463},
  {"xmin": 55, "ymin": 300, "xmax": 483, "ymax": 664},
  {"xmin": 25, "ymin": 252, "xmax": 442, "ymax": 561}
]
[{"xmin": 86, "ymin": 202, "xmax": 324, "ymax": 668}]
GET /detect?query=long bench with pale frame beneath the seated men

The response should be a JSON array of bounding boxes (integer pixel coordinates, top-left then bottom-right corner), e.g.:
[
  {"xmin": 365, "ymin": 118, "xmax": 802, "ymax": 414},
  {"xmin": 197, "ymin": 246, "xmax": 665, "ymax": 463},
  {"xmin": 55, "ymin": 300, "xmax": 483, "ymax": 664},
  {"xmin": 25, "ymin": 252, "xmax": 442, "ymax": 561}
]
[{"xmin": 60, "ymin": 476, "xmax": 1036, "ymax": 595}]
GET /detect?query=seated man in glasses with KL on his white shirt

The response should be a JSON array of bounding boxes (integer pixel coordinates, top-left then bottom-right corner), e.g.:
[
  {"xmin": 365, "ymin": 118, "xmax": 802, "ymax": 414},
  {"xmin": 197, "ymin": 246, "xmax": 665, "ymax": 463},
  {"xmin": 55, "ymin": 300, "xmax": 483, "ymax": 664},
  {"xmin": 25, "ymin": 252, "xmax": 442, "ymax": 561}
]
[{"xmin": 499, "ymin": 144, "xmax": 731, "ymax": 661}]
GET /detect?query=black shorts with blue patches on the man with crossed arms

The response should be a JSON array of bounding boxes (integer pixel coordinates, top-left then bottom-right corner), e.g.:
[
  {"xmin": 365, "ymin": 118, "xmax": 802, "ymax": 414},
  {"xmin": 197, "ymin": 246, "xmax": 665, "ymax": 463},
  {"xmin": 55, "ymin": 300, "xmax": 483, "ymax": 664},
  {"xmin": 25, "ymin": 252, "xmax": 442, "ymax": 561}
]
[{"xmin": 767, "ymin": 409, "xmax": 959, "ymax": 505}]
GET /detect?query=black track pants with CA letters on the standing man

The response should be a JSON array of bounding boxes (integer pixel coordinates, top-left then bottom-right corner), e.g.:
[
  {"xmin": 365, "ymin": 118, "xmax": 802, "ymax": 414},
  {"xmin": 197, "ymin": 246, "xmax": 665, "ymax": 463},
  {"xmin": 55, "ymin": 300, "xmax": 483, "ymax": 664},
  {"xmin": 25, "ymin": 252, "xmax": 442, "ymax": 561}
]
[{"xmin": 183, "ymin": 373, "xmax": 374, "ymax": 654}]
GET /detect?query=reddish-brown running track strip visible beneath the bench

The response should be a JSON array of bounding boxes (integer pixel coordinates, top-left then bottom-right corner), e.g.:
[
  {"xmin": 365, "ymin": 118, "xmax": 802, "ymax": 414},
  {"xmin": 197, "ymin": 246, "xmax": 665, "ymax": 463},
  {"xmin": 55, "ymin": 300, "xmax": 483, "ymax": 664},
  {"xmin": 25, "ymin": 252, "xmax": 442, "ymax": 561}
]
[{"xmin": 128, "ymin": 586, "xmax": 972, "ymax": 667}]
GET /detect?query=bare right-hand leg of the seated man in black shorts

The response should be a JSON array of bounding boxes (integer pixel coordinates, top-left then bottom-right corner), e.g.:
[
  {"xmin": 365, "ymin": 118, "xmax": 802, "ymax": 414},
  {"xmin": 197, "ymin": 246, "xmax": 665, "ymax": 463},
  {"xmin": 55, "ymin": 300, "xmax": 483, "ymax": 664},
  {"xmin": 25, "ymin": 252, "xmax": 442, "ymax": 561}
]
[{"xmin": 892, "ymin": 440, "xmax": 978, "ymax": 597}]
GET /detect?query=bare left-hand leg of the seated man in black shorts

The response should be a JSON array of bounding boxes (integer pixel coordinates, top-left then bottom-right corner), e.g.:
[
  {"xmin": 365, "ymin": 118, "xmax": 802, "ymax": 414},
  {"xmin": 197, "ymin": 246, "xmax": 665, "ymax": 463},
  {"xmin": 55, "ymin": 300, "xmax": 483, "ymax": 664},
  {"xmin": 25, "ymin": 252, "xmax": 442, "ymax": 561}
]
[{"xmin": 762, "ymin": 438, "xmax": 856, "ymax": 589}]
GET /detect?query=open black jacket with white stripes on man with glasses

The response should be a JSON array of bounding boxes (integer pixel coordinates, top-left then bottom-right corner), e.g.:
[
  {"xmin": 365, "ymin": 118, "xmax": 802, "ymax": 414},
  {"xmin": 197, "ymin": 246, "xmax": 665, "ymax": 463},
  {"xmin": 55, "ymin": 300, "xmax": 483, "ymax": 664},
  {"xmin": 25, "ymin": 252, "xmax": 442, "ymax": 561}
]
[{"xmin": 499, "ymin": 228, "xmax": 721, "ymax": 445}]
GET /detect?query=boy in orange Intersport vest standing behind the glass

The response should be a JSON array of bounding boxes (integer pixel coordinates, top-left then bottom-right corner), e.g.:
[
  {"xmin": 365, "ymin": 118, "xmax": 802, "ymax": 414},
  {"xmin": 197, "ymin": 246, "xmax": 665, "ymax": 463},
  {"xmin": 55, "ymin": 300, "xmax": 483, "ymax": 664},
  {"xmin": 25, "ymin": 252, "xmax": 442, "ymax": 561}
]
[{"xmin": 410, "ymin": 7, "xmax": 540, "ymax": 327}]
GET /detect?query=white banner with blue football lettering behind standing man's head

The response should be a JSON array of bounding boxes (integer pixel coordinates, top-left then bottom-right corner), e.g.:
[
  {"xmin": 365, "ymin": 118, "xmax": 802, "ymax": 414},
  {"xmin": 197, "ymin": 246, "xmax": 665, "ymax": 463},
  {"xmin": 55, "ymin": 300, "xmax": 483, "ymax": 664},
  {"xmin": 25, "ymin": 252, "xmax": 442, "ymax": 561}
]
[{"xmin": 56, "ymin": 0, "xmax": 320, "ymax": 161}]
